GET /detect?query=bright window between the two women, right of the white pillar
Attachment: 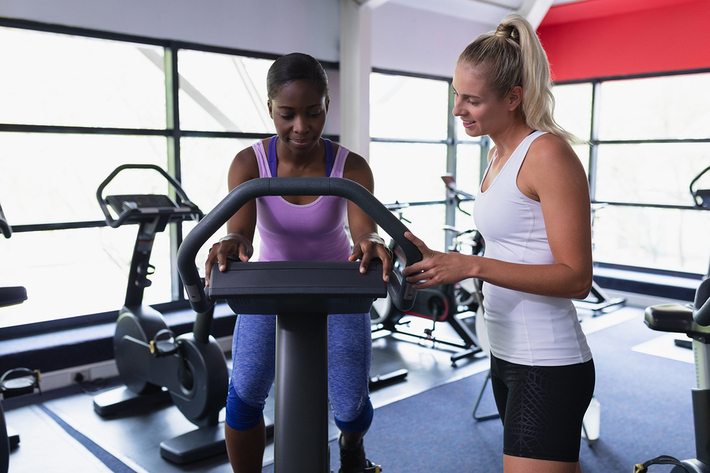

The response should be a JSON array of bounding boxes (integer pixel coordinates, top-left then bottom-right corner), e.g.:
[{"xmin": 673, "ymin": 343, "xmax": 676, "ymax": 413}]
[{"xmin": 370, "ymin": 72, "xmax": 481, "ymax": 250}]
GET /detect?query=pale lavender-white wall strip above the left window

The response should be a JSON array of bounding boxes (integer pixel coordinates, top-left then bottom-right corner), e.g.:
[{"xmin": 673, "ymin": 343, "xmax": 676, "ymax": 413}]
[{"xmin": 0, "ymin": 0, "xmax": 340, "ymax": 61}]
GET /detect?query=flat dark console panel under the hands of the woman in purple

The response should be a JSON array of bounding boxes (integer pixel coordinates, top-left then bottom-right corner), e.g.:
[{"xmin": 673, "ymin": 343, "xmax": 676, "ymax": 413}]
[{"xmin": 206, "ymin": 259, "xmax": 387, "ymax": 315}]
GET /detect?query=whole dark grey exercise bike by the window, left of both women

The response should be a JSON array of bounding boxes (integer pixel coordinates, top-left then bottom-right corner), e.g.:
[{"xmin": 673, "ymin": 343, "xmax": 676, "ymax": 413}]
[{"xmin": 94, "ymin": 164, "xmax": 229, "ymax": 464}]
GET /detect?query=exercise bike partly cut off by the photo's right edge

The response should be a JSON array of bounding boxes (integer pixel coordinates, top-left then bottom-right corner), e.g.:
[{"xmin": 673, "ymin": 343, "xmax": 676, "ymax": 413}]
[{"xmin": 634, "ymin": 167, "xmax": 710, "ymax": 473}]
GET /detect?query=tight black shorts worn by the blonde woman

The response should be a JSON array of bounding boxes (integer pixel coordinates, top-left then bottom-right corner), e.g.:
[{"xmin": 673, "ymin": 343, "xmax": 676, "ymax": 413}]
[{"xmin": 491, "ymin": 355, "xmax": 595, "ymax": 462}]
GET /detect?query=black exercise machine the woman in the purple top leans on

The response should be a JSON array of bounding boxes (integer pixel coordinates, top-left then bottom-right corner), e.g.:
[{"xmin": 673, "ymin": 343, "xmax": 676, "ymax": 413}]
[{"xmin": 178, "ymin": 177, "xmax": 421, "ymax": 473}]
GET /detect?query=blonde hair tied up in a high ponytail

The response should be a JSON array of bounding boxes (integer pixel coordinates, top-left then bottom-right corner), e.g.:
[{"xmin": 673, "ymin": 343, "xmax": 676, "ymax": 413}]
[{"xmin": 458, "ymin": 13, "xmax": 581, "ymax": 143}]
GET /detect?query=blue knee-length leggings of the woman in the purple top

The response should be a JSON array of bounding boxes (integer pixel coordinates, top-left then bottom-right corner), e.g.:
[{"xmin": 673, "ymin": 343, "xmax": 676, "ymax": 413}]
[{"xmin": 226, "ymin": 314, "xmax": 373, "ymax": 432}]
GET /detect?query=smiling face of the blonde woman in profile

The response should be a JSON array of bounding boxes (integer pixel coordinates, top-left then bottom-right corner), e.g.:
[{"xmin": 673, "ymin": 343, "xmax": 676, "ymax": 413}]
[{"xmin": 452, "ymin": 63, "xmax": 518, "ymax": 136}]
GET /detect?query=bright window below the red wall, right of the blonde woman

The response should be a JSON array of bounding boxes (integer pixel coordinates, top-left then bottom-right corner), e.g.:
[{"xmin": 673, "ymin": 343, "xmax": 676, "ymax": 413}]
[{"xmin": 554, "ymin": 73, "xmax": 710, "ymax": 275}]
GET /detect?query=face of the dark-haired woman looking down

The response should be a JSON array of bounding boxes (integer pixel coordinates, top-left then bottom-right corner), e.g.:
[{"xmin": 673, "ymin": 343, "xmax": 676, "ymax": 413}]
[{"xmin": 268, "ymin": 80, "xmax": 329, "ymax": 156}]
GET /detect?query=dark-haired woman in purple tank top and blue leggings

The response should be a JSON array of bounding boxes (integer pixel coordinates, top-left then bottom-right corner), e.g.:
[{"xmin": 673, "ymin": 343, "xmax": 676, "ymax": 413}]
[{"xmin": 205, "ymin": 53, "xmax": 392, "ymax": 473}]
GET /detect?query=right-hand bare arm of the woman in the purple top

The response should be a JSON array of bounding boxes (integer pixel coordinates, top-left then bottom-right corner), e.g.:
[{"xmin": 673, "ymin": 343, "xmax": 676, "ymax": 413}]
[{"xmin": 343, "ymin": 153, "xmax": 392, "ymax": 281}]
